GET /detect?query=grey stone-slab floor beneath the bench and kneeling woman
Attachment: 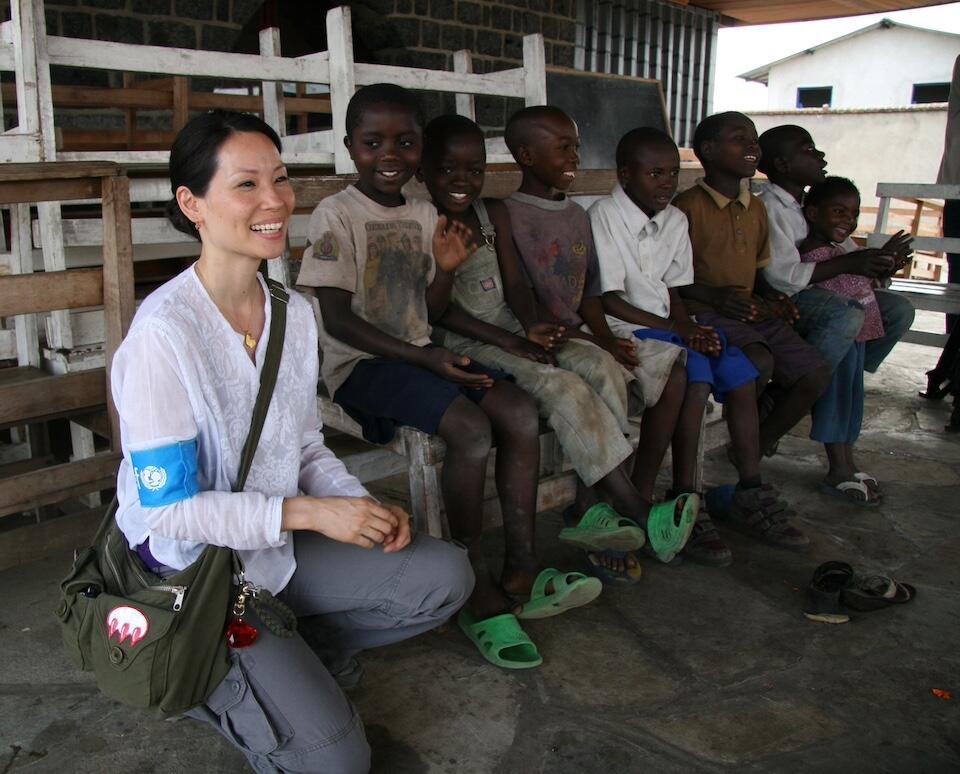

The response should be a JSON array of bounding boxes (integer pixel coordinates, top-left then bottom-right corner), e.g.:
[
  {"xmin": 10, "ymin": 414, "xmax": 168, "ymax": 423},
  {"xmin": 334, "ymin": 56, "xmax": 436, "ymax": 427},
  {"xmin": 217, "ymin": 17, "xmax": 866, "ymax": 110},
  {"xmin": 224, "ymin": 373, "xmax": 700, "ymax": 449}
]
[{"xmin": 0, "ymin": 334, "xmax": 960, "ymax": 774}]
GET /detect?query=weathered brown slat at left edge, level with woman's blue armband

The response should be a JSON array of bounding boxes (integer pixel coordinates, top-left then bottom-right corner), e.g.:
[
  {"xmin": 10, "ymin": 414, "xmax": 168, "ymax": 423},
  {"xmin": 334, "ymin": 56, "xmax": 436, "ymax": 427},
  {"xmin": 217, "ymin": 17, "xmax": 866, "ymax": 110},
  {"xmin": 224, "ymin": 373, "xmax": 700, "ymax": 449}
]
[{"xmin": 0, "ymin": 452, "xmax": 122, "ymax": 517}]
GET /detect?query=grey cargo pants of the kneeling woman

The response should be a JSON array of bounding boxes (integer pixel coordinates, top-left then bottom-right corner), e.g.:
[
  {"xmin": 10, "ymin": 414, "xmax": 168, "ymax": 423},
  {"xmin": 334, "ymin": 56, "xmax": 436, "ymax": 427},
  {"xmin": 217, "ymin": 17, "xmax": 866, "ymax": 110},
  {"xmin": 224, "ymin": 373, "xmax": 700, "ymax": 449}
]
[{"xmin": 187, "ymin": 532, "xmax": 474, "ymax": 774}]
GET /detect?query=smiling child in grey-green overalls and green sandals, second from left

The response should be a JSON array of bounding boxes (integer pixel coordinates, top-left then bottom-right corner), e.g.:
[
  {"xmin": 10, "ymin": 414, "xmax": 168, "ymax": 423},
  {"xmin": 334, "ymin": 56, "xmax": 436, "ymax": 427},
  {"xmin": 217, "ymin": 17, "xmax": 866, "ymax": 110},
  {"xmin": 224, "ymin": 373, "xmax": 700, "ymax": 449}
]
[{"xmin": 422, "ymin": 116, "xmax": 686, "ymax": 583}]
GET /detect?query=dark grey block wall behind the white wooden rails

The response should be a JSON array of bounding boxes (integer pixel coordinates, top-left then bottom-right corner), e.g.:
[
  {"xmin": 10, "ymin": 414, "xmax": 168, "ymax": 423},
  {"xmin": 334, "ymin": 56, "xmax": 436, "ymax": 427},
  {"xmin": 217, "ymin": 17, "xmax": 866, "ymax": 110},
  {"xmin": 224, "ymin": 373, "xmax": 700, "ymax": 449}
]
[{"xmin": 0, "ymin": 0, "xmax": 576, "ymax": 129}]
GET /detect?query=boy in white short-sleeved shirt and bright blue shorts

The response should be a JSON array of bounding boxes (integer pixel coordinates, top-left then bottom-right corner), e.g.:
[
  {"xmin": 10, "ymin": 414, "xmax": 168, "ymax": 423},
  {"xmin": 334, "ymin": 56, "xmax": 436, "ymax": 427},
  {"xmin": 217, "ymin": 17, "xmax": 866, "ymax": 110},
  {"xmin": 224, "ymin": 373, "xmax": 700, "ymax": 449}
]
[{"xmin": 590, "ymin": 128, "xmax": 772, "ymax": 566}]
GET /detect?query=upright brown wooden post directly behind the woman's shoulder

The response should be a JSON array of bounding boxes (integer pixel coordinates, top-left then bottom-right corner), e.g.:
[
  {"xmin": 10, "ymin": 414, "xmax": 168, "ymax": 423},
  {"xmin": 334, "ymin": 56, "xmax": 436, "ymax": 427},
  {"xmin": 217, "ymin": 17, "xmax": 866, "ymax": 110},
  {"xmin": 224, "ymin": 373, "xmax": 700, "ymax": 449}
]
[{"xmin": 101, "ymin": 172, "xmax": 135, "ymax": 451}]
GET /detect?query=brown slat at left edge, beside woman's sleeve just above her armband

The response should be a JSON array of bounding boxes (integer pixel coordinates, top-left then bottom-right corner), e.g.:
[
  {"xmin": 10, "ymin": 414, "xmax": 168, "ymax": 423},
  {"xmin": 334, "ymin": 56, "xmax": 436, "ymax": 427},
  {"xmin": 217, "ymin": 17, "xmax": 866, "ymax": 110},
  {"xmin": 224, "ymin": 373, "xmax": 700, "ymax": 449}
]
[{"xmin": 0, "ymin": 366, "xmax": 107, "ymax": 426}]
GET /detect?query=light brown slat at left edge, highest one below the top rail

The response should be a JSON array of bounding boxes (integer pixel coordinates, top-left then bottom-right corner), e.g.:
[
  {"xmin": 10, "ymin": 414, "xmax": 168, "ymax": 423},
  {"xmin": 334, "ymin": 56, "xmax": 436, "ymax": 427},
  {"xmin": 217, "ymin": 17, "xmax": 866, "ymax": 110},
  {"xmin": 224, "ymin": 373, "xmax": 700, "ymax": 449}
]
[{"xmin": 0, "ymin": 269, "xmax": 103, "ymax": 317}]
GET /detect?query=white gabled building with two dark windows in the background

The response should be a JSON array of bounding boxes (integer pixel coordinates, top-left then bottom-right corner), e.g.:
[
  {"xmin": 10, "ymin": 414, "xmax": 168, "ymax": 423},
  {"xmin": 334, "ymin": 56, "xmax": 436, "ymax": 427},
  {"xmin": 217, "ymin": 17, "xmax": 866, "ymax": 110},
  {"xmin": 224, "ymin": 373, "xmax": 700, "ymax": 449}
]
[{"xmin": 739, "ymin": 19, "xmax": 960, "ymax": 110}]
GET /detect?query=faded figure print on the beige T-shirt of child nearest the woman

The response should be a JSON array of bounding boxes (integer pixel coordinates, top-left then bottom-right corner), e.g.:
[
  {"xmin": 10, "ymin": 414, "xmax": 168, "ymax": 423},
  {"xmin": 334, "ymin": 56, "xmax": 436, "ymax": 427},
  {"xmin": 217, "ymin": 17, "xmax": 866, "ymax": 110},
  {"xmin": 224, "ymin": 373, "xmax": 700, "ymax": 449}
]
[{"xmin": 363, "ymin": 220, "xmax": 431, "ymax": 340}]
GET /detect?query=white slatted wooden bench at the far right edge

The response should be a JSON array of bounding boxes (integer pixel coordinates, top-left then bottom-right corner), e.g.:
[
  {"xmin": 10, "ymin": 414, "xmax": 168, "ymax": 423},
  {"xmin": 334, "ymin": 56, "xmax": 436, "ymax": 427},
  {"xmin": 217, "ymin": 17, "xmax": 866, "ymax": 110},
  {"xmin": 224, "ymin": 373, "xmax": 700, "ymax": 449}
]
[{"xmin": 867, "ymin": 183, "xmax": 960, "ymax": 347}]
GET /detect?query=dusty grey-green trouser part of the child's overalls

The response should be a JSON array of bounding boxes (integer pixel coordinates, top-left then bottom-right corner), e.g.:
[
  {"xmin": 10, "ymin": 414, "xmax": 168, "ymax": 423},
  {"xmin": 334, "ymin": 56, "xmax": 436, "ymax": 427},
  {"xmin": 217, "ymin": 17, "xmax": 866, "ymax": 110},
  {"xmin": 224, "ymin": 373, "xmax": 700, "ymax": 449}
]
[{"xmin": 444, "ymin": 336, "xmax": 633, "ymax": 486}]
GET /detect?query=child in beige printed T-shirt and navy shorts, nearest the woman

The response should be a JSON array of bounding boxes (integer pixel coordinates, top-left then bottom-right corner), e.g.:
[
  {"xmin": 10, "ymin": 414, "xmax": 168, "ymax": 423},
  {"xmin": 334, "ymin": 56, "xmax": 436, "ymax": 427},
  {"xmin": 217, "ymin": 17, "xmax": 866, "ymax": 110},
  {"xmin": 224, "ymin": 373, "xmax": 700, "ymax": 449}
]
[{"xmin": 298, "ymin": 84, "xmax": 601, "ymax": 669}]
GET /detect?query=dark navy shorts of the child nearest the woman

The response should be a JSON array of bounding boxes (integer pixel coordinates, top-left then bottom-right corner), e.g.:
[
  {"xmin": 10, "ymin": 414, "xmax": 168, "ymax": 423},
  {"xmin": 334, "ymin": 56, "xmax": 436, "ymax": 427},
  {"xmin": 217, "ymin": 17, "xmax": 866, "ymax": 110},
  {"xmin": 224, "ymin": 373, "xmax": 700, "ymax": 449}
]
[{"xmin": 333, "ymin": 357, "xmax": 512, "ymax": 443}]
